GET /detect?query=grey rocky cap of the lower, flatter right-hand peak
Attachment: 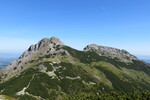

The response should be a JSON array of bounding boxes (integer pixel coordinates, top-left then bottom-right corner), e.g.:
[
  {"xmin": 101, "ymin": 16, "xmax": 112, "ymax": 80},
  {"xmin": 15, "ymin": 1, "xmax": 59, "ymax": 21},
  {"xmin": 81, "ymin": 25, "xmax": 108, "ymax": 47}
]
[{"xmin": 84, "ymin": 44, "xmax": 139, "ymax": 62}]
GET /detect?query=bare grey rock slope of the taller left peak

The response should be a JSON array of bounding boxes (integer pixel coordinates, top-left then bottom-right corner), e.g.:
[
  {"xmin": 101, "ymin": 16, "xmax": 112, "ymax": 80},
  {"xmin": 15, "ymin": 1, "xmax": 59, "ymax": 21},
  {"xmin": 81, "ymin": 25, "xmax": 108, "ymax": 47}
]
[{"xmin": 0, "ymin": 37, "xmax": 64, "ymax": 81}]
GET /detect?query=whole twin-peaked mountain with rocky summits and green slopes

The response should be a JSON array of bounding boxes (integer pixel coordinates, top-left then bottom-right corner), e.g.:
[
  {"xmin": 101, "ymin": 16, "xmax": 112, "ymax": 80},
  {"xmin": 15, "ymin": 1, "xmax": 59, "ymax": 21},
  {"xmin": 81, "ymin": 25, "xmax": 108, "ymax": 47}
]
[{"xmin": 0, "ymin": 37, "xmax": 150, "ymax": 100}]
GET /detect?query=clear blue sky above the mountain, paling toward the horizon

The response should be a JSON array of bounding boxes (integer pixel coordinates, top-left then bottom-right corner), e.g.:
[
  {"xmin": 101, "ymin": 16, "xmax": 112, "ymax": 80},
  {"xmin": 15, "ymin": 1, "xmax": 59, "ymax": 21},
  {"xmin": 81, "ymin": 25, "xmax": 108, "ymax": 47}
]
[{"xmin": 0, "ymin": 0, "xmax": 150, "ymax": 56}]
